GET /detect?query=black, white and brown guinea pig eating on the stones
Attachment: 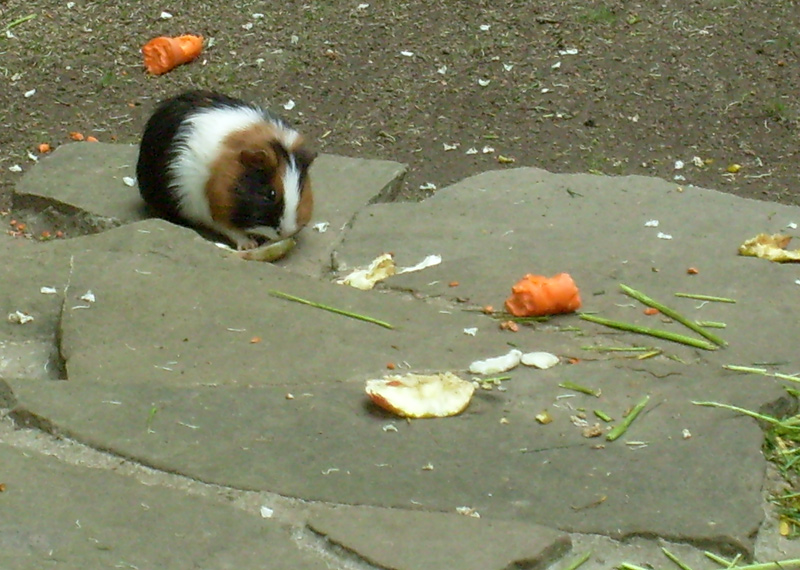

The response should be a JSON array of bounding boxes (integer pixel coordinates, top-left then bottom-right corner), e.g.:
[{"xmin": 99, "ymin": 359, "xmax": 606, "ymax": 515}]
[{"xmin": 136, "ymin": 91, "xmax": 316, "ymax": 250}]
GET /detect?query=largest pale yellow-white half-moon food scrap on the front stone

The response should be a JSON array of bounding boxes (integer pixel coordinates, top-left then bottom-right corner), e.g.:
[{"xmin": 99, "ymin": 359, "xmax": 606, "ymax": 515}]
[{"xmin": 365, "ymin": 372, "xmax": 475, "ymax": 418}]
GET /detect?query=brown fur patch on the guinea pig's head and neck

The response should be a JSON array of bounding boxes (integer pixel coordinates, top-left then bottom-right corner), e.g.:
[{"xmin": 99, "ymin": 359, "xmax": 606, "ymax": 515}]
[{"xmin": 205, "ymin": 122, "xmax": 286, "ymax": 229}]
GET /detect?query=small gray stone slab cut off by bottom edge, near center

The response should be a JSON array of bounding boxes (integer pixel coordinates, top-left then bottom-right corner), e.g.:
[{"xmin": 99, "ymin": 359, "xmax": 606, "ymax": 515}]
[{"xmin": 308, "ymin": 506, "xmax": 570, "ymax": 570}]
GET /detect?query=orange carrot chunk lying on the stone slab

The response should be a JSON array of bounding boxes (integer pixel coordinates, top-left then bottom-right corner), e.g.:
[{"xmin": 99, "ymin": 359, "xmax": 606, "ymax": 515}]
[{"xmin": 506, "ymin": 273, "xmax": 581, "ymax": 317}]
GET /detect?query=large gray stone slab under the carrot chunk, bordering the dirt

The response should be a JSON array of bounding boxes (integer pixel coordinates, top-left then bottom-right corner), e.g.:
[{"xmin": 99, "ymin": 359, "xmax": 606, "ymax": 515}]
[{"xmin": 336, "ymin": 168, "xmax": 800, "ymax": 363}]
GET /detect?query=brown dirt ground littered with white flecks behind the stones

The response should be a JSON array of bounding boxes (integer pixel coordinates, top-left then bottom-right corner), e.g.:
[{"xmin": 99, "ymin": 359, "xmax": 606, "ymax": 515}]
[{"xmin": 0, "ymin": 0, "xmax": 800, "ymax": 213}]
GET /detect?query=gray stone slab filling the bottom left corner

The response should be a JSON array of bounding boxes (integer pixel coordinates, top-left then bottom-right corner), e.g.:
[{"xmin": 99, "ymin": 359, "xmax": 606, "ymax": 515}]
[{"xmin": 0, "ymin": 443, "xmax": 329, "ymax": 570}]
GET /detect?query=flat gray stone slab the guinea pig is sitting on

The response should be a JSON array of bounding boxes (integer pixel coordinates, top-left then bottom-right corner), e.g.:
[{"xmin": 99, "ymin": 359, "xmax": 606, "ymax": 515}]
[{"xmin": 14, "ymin": 143, "xmax": 406, "ymax": 276}]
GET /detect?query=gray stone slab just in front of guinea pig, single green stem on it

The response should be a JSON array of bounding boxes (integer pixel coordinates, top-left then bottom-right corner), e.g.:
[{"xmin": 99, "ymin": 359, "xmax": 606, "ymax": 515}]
[{"xmin": 47, "ymin": 220, "xmax": 506, "ymax": 390}]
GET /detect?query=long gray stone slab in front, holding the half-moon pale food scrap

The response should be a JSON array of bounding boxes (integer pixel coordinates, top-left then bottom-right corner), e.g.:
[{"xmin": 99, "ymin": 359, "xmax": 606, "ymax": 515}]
[{"xmin": 6, "ymin": 361, "xmax": 781, "ymax": 552}]
